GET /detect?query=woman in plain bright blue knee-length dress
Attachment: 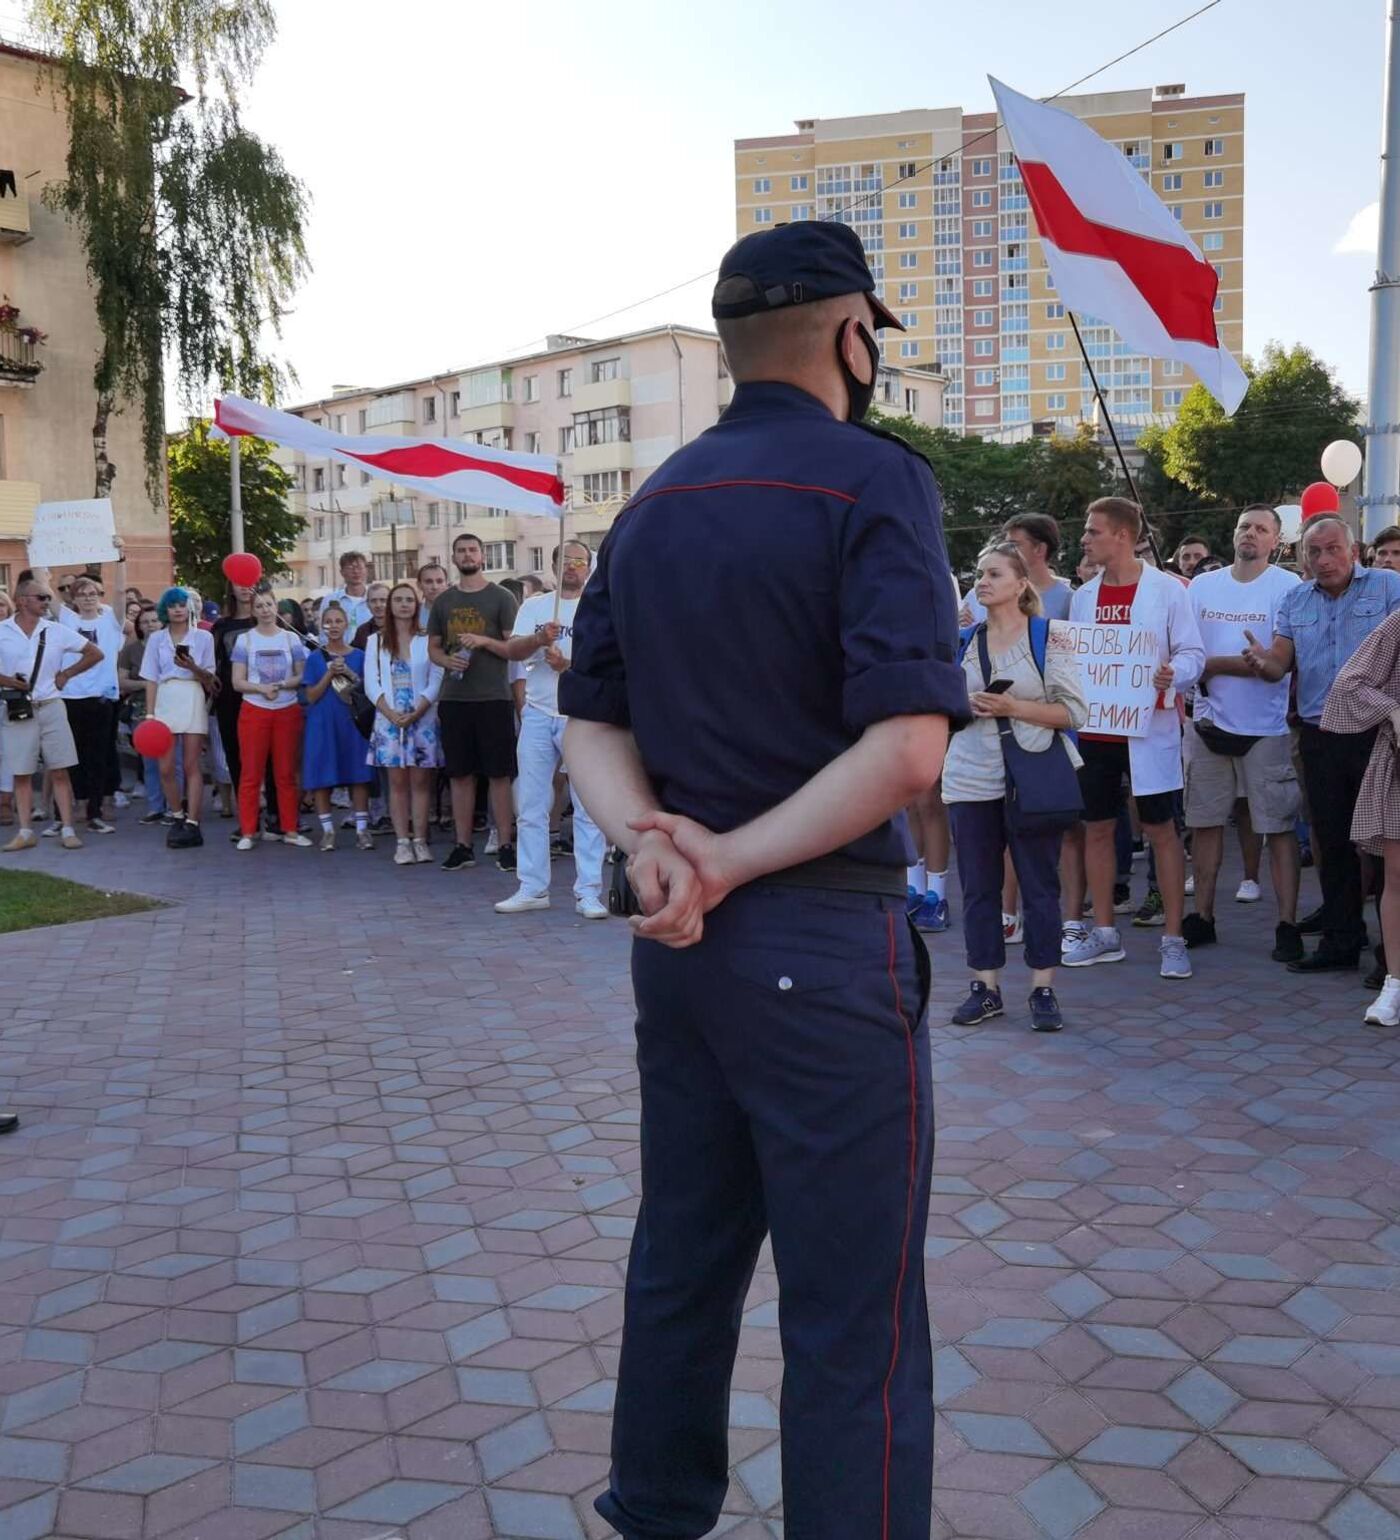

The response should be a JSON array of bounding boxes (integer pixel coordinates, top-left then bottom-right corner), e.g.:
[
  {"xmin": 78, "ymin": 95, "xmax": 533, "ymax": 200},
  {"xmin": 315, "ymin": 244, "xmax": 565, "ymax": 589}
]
[{"xmin": 302, "ymin": 599, "xmax": 374, "ymax": 850}]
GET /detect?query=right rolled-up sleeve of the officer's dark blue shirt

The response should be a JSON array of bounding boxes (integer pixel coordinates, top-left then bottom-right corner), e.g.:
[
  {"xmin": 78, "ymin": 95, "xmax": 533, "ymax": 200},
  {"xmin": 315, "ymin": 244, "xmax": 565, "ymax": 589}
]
[{"xmin": 838, "ymin": 453, "xmax": 972, "ymax": 733}]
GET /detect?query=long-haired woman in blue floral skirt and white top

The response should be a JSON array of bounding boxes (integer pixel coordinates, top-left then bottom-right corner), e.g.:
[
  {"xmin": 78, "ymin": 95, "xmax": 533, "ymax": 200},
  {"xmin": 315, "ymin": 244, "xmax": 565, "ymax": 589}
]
[{"xmin": 365, "ymin": 582, "xmax": 442, "ymax": 865}]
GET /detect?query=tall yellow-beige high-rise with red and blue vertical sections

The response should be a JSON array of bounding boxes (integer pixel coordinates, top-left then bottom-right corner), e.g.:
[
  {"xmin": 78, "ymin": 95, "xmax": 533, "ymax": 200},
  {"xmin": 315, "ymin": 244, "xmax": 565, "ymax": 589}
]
[{"xmin": 735, "ymin": 85, "xmax": 1244, "ymax": 437}]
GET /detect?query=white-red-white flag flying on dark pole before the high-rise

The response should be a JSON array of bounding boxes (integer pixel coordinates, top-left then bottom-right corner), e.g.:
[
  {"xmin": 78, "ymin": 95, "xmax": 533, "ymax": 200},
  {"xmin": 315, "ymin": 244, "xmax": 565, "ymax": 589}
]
[{"xmin": 987, "ymin": 75, "xmax": 1249, "ymax": 413}]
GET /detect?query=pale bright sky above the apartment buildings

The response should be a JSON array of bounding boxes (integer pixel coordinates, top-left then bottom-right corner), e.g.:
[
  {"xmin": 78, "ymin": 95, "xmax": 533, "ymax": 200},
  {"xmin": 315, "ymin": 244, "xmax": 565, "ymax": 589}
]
[{"xmin": 235, "ymin": 0, "xmax": 1385, "ymax": 399}]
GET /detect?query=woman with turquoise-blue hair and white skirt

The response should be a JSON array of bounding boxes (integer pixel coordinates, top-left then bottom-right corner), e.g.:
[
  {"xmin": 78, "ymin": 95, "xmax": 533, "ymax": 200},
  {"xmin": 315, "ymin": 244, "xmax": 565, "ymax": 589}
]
[{"xmin": 142, "ymin": 588, "xmax": 214, "ymax": 850}]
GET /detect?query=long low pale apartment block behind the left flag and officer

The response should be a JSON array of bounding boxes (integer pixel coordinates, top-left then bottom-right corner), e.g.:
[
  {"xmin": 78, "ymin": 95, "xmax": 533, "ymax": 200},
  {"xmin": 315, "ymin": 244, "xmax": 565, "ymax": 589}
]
[{"xmin": 279, "ymin": 326, "xmax": 944, "ymax": 596}]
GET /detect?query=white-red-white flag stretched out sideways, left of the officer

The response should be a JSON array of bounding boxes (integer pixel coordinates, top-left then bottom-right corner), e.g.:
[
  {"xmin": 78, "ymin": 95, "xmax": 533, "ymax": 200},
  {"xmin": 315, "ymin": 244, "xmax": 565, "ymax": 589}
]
[{"xmin": 214, "ymin": 396, "xmax": 564, "ymax": 519}]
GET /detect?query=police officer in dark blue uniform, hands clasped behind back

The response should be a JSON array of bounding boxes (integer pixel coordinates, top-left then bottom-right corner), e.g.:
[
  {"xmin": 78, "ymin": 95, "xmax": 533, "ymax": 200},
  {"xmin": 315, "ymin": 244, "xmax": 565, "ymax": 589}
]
[{"xmin": 559, "ymin": 223, "xmax": 967, "ymax": 1540}]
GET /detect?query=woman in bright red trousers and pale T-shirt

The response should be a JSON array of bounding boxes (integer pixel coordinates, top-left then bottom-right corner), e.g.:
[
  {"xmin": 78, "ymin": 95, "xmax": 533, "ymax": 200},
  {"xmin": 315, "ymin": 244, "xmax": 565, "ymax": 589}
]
[{"xmin": 233, "ymin": 591, "xmax": 311, "ymax": 850}]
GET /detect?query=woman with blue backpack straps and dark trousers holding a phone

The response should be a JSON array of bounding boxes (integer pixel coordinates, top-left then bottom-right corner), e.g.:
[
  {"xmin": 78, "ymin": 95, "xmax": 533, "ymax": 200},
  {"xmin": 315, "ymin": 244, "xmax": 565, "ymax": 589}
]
[{"xmin": 943, "ymin": 541, "xmax": 1089, "ymax": 1032}]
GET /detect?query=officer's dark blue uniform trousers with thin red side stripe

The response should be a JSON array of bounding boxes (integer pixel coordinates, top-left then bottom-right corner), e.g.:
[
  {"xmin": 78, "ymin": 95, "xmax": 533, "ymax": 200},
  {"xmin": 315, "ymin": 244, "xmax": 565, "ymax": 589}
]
[{"xmin": 596, "ymin": 886, "xmax": 933, "ymax": 1540}]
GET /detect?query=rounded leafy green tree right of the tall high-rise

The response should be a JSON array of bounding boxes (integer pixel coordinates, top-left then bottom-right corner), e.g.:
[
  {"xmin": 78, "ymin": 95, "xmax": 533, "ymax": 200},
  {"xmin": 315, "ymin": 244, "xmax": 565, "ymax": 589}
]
[{"xmin": 1160, "ymin": 342, "xmax": 1360, "ymax": 508}]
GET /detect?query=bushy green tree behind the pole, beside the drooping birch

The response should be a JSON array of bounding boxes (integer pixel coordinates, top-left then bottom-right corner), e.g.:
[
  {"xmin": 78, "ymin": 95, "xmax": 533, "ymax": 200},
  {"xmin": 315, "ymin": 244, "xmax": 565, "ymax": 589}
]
[{"xmin": 168, "ymin": 417, "xmax": 303, "ymax": 599}]
